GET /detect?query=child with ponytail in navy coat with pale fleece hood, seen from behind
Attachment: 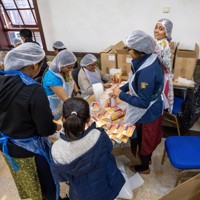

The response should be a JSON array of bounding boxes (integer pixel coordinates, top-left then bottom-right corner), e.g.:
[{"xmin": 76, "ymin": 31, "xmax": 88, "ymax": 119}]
[{"xmin": 51, "ymin": 97, "xmax": 125, "ymax": 200}]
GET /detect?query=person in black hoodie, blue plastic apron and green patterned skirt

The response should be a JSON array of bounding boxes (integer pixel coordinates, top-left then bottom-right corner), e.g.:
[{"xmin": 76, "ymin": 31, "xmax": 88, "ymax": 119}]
[{"xmin": 0, "ymin": 43, "xmax": 64, "ymax": 200}]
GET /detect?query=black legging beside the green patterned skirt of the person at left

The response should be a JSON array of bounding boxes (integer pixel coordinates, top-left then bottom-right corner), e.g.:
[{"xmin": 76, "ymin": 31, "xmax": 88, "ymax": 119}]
[{"xmin": 35, "ymin": 155, "xmax": 56, "ymax": 200}]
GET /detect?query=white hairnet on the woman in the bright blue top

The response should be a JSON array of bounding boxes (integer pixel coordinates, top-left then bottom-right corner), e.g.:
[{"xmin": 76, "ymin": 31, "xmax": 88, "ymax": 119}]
[{"xmin": 49, "ymin": 50, "xmax": 77, "ymax": 73}]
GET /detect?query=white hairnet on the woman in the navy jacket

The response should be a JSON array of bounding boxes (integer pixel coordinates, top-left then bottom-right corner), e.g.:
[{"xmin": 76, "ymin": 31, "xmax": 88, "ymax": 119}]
[{"xmin": 126, "ymin": 30, "xmax": 156, "ymax": 54}]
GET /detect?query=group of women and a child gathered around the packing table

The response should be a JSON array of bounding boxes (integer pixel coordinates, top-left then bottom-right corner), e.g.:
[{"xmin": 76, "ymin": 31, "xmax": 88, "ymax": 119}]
[{"xmin": 0, "ymin": 19, "xmax": 173, "ymax": 200}]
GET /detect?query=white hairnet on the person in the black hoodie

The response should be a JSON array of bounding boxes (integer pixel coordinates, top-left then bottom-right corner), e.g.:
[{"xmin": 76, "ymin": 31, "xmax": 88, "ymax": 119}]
[{"xmin": 4, "ymin": 42, "xmax": 45, "ymax": 71}]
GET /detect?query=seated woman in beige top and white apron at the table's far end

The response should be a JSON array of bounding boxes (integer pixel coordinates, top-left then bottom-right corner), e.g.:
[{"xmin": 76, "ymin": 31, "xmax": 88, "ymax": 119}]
[{"xmin": 78, "ymin": 54, "xmax": 111, "ymax": 98}]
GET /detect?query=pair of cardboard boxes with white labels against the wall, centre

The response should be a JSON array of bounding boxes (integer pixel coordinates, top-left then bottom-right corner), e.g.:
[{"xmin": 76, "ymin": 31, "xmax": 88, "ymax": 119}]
[{"xmin": 100, "ymin": 41, "xmax": 132, "ymax": 76}]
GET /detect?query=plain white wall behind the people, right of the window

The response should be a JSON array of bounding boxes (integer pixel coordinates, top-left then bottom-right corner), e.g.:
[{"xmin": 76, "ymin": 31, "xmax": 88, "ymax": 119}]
[{"xmin": 38, "ymin": 0, "xmax": 200, "ymax": 53}]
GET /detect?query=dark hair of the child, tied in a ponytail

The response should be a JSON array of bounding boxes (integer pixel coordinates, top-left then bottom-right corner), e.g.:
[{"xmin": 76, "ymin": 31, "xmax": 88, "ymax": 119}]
[{"xmin": 63, "ymin": 97, "xmax": 90, "ymax": 140}]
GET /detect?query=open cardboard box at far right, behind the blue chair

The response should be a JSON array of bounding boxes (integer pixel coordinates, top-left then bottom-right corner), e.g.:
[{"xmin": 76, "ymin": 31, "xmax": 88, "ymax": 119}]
[{"xmin": 174, "ymin": 43, "xmax": 199, "ymax": 80}]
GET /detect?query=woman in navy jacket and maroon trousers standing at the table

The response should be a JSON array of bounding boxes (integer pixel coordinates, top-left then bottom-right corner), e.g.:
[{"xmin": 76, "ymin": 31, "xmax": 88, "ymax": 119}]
[{"xmin": 111, "ymin": 30, "xmax": 163, "ymax": 174}]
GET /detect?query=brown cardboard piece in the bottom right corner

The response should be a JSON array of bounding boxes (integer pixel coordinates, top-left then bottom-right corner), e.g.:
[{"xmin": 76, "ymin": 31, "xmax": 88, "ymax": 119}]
[{"xmin": 160, "ymin": 174, "xmax": 200, "ymax": 200}]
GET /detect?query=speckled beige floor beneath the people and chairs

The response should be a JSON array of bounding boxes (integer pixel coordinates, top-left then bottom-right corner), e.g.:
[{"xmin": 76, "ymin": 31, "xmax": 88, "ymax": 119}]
[{"xmin": 0, "ymin": 125, "xmax": 200, "ymax": 200}]
